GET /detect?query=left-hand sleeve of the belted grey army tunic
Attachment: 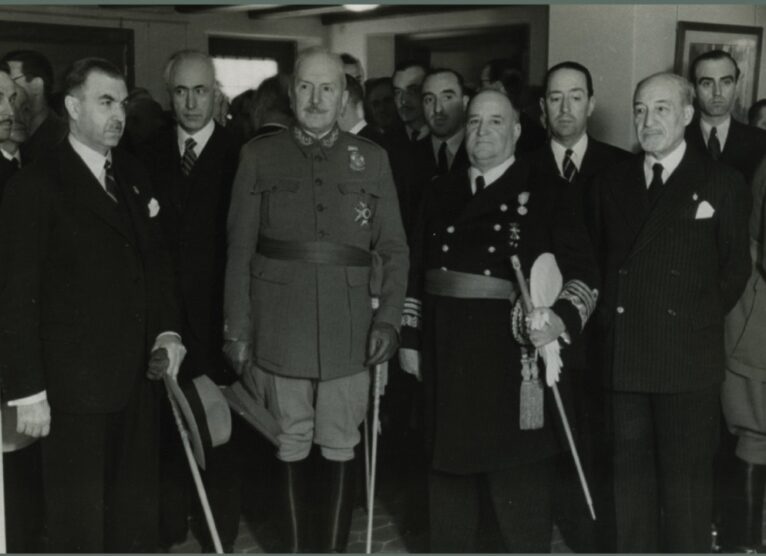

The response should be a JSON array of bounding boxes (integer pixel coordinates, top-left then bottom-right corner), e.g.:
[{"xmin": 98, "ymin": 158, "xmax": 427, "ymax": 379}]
[{"xmin": 224, "ymin": 144, "xmax": 261, "ymax": 341}]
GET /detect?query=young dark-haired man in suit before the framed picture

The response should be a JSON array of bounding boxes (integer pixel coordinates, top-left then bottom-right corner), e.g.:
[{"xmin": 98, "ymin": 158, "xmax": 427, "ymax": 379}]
[{"xmin": 686, "ymin": 50, "xmax": 766, "ymax": 182}]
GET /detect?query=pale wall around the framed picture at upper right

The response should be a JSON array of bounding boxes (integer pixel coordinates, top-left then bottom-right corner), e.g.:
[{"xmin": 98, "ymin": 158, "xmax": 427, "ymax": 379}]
[{"xmin": 548, "ymin": 4, "xmax": 766, "ymax": 149}]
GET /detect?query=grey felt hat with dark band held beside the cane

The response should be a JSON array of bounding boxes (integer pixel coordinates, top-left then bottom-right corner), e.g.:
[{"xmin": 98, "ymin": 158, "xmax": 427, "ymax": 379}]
[{"xmin": 163, "ymin": 375, "xmax": 231, "ymax": 469}]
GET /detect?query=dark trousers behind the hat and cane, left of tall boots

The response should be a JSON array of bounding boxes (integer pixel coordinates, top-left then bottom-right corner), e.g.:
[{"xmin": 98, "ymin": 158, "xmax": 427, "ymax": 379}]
[{"xmin": 160, "ymin": 399, "xmax": 244, "ymax": 550}]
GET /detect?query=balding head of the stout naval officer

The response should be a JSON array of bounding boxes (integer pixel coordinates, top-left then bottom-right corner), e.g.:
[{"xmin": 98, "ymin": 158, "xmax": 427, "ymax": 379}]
[{"xmin": 465, "ymin": 90, "xmax": 521, "ymax": 172}]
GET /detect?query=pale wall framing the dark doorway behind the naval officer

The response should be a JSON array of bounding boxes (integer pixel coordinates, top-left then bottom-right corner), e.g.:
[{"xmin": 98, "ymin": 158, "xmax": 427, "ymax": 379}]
[{"xmin": 328, "ymin": 6, "xmax": 548, "ymax": 84}]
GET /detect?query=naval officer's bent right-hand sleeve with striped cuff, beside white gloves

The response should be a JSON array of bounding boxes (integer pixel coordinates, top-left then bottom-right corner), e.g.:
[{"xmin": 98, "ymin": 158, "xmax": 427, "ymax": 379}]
[{"xmin": 551, "ymin": 180, "xmax": 598, "ymax": 340}]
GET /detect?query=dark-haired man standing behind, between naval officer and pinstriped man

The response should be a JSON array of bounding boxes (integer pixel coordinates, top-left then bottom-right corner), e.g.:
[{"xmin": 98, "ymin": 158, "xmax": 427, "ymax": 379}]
[{"xmin": 522, "ymin": 61, "xmax": 630, "ymax": 552}]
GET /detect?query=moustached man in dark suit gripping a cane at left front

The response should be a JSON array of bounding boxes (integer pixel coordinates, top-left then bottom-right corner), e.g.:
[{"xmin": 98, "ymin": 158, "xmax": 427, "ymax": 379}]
[{"xmin": 0, "ymin": 58, "xmax": 185, "ymax": 552}]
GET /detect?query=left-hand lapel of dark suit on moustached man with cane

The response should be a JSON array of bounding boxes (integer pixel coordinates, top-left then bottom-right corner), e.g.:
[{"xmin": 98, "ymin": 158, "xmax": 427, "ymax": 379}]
[{"xmin": 61, "ymin": 141, "xmax": 132, "ymax": 240}]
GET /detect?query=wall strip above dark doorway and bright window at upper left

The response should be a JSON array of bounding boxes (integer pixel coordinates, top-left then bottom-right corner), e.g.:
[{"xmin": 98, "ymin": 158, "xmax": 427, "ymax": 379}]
[{"xmin": 0, "ymin": 6, "xmax": 327, "ymax": 105}]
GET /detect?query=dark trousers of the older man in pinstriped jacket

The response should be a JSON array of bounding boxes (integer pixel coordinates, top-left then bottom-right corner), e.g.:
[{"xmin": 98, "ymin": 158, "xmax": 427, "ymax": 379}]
[{"xmin": 608, "ymin": 385, "xmax": 720, "ymax": 552}]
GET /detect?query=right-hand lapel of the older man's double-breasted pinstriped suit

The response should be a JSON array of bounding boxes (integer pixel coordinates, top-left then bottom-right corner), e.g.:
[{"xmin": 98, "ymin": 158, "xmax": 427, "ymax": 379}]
[{"xmin": 631, "ymin": 147, "xmax": 704, "ymax": 256}]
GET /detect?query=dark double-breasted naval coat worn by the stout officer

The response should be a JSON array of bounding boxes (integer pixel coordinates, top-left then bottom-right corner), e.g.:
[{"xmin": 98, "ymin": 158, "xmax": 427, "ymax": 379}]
[{"xmin": 402, "ymin": 160, "xmax": 597, "ymax": 474}]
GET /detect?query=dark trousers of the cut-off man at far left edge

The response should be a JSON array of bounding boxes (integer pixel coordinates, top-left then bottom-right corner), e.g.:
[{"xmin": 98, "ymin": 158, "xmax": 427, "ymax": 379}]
[{"xmin": 3, "ymin": 442, "xmax": 44, "ymax": 553}]
